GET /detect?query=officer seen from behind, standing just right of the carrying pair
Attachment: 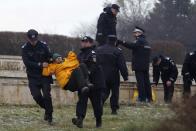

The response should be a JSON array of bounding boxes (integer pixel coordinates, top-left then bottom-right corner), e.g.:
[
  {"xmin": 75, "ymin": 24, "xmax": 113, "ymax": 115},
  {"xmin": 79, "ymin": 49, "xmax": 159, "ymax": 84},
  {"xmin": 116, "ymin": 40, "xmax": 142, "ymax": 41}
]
[{"xmin": 97, "ymin": 37, "xmax": 128, "ymax": 115}]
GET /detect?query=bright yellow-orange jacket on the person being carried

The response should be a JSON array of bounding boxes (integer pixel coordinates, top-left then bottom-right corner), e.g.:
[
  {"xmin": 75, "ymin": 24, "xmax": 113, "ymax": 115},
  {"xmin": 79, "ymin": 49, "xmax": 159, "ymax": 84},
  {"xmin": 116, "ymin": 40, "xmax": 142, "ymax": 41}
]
[{"xmin": 42, "ymin": 51, "xmax": 79, "ymax": 88}]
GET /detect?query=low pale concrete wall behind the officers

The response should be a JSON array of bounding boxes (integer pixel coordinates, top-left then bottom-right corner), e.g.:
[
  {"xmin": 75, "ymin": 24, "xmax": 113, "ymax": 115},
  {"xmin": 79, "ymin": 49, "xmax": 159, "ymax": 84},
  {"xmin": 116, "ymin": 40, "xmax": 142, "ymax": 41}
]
[{"xmin": 0, "ymin": 56, "xmax": 195, "ymax": 105}]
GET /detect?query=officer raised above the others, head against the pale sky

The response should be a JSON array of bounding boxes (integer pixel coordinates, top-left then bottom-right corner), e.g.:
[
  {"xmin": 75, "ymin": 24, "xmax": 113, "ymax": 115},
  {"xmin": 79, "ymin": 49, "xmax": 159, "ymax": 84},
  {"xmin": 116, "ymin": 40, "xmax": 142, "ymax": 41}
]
[{"xmin": 96, "ymin": 4, "xmax": 120, "ymax": 45}]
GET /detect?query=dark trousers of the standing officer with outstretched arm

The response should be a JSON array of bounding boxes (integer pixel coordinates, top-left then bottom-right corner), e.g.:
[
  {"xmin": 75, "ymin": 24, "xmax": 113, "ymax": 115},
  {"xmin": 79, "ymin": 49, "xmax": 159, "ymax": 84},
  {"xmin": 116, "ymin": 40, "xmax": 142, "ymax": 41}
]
[{"xmin": 135, "ymin": 71, "xmax": 152, "ymax": 102}]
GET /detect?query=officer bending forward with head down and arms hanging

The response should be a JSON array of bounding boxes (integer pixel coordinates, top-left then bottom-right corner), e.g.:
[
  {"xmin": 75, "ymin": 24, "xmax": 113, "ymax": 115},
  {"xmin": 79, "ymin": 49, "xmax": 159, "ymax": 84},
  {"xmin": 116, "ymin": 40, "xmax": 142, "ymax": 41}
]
[{"xmin": 153, "ymin": 55, "xmax": 178, "ymax": 103}]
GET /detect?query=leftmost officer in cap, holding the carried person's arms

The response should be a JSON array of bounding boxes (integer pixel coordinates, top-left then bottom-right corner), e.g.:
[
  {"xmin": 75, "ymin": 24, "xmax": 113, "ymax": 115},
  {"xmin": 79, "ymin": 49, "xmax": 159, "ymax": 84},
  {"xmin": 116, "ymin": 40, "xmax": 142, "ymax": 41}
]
[{"xmin": 22, "ymin": 29, "xmax": 53, "ymax": 124}]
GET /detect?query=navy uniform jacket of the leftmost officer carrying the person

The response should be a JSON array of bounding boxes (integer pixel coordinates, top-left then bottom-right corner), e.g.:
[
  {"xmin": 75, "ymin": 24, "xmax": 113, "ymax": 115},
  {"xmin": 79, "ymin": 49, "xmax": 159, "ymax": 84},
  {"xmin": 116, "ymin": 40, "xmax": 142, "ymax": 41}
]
[{"xmin": 22, "ymin": 41, "xmax": 51, "ymax": 80}]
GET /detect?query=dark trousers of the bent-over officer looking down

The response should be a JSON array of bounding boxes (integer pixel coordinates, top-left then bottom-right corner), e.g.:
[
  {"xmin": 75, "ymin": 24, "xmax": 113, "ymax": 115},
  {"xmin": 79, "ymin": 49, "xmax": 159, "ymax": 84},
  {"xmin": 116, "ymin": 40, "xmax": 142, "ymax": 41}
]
[{"xmin": 163, "ymin": 81, "xmax": 174, "ymax": 103}]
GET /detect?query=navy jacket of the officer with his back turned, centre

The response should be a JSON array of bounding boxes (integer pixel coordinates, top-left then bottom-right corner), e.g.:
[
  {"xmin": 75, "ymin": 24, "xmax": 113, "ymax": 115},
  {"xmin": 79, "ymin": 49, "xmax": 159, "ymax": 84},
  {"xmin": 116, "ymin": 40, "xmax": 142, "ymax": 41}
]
[{"xmin": 97, "ymin": 44, "xmax": 128, "ymax": 81}]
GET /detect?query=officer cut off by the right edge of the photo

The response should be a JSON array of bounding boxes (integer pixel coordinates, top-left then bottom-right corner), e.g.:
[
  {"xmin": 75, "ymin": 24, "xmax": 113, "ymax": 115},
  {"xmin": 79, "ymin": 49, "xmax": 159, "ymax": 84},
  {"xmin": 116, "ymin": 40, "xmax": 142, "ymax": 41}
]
[{"xmin": 182, "ymin": 51, "xmax": 196, "ymax": 98}]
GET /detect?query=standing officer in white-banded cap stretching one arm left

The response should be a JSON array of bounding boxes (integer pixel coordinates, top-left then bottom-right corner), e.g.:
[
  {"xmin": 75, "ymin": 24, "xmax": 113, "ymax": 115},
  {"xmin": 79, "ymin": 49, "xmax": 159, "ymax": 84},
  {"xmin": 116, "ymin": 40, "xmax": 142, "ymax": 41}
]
[{"xmin": 117, "ymin": 27, "xmax": 152, "ymax": 103}]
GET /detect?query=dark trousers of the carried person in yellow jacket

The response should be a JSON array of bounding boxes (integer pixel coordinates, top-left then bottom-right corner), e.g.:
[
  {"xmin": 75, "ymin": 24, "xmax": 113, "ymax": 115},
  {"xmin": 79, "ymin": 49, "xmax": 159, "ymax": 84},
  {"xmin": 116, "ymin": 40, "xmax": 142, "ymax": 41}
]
[{"xmin": 64, "ymin": 64, "xmax": 88, "ymax": 92}]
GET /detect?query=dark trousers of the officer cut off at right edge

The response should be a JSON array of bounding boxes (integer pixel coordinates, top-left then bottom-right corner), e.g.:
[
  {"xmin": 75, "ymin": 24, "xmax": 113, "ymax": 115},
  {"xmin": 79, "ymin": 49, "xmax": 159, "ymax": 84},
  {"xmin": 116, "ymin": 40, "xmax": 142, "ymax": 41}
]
[{"xmin": 183, "ymin": 76, "xmax": 196, "ymax": 97}]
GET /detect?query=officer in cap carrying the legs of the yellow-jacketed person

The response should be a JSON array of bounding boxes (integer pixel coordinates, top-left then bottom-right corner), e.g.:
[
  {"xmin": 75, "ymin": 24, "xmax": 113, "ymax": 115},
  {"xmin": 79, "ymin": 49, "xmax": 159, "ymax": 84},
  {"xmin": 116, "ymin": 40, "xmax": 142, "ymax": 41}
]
[{"xmin": 72, "ymin": 36, "xmax": 105, "ymax": 128}]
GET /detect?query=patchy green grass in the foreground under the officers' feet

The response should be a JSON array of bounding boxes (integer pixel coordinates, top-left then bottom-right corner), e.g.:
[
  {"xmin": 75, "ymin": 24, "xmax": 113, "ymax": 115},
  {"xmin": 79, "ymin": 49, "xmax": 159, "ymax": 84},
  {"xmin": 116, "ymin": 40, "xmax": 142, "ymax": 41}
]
[{"xmin": 0, "ymin": 105, "xmax": 174, "ymax": 131}]
